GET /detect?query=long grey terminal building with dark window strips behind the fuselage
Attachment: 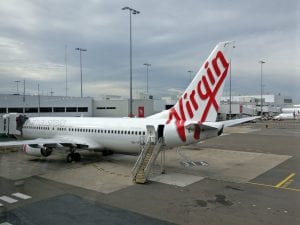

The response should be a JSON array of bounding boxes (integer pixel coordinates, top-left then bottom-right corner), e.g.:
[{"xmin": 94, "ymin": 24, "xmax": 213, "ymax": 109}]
[{"xmin": 0, "ymin": 94, "xmax": 154, "ymax": 117}]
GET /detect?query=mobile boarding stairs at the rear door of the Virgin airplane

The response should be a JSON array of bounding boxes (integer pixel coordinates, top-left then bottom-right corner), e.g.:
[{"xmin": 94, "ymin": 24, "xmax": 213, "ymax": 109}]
[{"xmin": 132, "ymin": 125, "xmax": 164, "ymax": 184}]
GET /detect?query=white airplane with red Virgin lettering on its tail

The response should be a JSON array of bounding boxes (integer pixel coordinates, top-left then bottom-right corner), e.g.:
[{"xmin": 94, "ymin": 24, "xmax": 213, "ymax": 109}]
[{"xmin": 0, "ymin": 41, "xmax": 259, "ymax": 162}]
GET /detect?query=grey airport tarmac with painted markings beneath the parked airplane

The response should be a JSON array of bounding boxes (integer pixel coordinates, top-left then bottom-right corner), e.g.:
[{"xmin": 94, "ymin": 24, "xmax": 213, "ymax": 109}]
[{"xmin": 0, "ymin": 121, "xmax": 300, "ymax": 225}]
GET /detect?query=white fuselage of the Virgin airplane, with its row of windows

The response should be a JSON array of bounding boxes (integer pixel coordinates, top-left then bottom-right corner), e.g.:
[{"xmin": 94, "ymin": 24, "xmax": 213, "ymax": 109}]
[{"xmin": 22, "ymin": 117, "xmax": 213, "ymax": 153}]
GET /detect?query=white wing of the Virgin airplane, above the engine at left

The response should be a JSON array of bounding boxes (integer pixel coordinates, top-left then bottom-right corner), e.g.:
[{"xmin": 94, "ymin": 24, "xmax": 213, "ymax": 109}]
[{"xmin": 0, "ymin": 136, "xmax": 101, "ymax": 149}]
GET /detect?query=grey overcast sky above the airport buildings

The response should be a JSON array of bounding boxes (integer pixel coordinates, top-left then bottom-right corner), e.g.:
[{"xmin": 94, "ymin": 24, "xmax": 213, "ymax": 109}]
[{"xmin": 0, "ymin": 0, "xmax": 300, "ymax": 103}]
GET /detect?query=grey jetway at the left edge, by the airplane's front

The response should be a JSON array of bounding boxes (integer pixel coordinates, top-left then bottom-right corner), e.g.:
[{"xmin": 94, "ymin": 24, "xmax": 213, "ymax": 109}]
[{"xmin": 0, "ymin": 113, "xmax": 28, "ymax": 136}]
